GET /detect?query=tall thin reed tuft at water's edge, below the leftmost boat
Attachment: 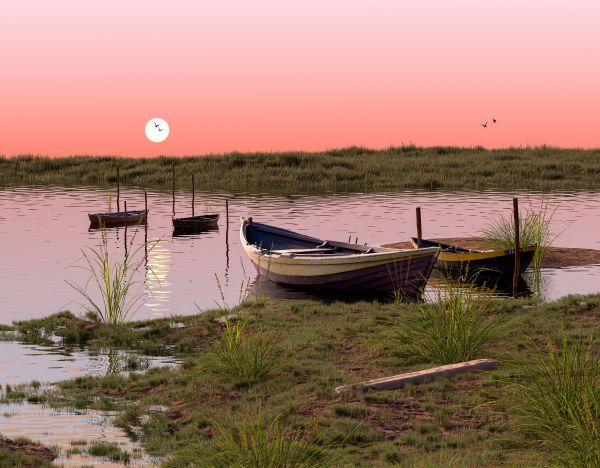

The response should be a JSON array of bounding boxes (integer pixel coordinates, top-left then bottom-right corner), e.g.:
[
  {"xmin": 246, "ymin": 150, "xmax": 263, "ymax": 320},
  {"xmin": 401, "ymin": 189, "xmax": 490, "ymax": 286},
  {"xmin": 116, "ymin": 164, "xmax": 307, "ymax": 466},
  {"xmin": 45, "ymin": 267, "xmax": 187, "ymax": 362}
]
[{"xmin": 67, "ymin": 229, "xmax": 158, "ymax": 325}]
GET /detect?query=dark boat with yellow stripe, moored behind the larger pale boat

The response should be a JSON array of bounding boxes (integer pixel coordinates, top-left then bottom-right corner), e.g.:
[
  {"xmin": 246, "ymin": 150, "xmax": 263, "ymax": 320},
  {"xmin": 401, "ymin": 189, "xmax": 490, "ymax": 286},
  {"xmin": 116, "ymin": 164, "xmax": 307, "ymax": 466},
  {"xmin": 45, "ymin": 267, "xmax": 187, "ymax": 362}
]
[{"xmin": 411, "ymin": 237, "xmax": 536, "ymax": 282}]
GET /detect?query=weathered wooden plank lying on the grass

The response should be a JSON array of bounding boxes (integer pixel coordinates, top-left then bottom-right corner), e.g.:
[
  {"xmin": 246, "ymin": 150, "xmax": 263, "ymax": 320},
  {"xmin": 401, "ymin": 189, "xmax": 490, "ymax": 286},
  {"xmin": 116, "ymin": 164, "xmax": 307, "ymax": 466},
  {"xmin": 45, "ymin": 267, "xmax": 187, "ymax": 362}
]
[{"xmin": 335, "ymin": 359, "xmax": 497, "ymax": 393}]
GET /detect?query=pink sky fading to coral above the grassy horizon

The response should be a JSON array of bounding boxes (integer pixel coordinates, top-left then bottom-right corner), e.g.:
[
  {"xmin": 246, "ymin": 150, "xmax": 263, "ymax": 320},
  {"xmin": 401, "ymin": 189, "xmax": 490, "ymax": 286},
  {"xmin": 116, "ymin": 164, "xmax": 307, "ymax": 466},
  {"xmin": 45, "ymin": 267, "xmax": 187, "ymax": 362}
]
[{"xmin": 0, "ymin": 0, "xmax": 600, "ymax": 156}]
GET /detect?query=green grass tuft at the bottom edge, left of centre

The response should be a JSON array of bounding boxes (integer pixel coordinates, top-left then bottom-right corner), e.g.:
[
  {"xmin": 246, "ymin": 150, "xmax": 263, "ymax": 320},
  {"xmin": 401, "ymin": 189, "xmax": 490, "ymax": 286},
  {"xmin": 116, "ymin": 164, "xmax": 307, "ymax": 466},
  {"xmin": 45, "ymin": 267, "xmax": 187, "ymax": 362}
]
[{"xmin": 173, "ymin": 414, "xmax": 334, "ymax": 468}]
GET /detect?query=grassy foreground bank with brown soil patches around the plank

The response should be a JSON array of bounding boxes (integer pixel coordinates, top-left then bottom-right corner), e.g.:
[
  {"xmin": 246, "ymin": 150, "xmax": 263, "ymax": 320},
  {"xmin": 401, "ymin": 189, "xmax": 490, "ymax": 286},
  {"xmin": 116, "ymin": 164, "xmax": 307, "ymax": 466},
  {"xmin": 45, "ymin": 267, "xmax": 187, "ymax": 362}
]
[{"xmin": 2, "ymin": 296, "xmax": 600, "ymax": 467}]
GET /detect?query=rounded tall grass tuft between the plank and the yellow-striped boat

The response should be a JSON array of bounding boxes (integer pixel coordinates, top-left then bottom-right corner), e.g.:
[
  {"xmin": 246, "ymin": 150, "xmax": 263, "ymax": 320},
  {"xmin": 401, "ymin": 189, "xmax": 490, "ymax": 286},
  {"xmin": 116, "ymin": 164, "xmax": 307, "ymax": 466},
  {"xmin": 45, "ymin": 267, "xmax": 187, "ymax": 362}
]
[{"xmin": 395, "ymin": 283, "xmax": 500, "ymax": 364}]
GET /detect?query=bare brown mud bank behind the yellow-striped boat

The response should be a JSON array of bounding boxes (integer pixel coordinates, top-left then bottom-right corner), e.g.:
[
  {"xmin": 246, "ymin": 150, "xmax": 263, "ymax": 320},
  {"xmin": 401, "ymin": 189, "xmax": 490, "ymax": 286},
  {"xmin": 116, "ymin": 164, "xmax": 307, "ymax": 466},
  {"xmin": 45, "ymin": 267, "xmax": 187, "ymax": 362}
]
[{"xmin": 383, "ymin": 237, "xmax": 600, "ymax": 268}]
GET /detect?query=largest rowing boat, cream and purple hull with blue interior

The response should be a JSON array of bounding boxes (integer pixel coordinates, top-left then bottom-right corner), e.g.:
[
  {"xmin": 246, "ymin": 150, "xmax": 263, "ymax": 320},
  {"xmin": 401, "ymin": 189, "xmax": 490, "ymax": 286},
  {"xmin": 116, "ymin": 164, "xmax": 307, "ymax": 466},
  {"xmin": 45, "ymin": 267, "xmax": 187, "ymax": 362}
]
[{"xmin": 240, "ymin": 218, "xmax": 439, "ymax": 296}]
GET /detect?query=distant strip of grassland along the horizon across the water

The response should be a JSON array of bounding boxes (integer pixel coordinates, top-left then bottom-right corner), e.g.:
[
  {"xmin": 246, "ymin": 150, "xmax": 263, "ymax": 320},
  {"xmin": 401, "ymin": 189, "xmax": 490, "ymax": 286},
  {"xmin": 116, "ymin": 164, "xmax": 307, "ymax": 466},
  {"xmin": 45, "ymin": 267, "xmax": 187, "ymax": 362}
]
[{"xmin": 0, "ymin": 146, "xmax": 600, "ymax": 193}]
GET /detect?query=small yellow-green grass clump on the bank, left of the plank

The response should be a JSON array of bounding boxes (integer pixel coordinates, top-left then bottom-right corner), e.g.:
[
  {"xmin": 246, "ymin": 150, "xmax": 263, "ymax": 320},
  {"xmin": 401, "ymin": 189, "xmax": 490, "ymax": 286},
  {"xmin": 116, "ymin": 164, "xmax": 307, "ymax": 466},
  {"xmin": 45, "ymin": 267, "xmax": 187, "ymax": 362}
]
[{"xmin": 204, "ymin": 314, "xmax": 280, "ymax": 383}]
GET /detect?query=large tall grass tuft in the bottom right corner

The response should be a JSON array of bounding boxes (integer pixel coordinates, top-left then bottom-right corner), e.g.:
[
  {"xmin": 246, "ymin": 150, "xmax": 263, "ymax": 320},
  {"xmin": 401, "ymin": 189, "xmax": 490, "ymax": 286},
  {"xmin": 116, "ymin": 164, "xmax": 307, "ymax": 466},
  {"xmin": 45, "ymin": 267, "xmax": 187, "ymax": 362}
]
[{"xmin": 508, "ymin": 331, "xmax": 600, "ymax": 467}]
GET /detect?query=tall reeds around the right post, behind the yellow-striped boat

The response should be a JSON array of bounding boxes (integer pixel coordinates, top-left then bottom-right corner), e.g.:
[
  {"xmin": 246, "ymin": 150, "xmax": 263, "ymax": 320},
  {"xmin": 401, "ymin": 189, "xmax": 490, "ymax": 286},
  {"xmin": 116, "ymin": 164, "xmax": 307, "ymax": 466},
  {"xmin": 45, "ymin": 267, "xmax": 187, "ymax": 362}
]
[{"xmin": 480, "ymin": 200, "xmax": 557, "ymax": 271}]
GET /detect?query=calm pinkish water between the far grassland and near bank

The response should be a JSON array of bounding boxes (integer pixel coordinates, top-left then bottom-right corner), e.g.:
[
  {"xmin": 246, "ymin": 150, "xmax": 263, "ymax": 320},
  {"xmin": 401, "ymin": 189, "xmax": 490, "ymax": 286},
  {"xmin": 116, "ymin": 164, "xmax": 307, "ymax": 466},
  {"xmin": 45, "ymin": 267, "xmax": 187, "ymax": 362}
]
[{"xmin": 0, "ymin": 187, "xmax": 600, "ymax": 323}]
